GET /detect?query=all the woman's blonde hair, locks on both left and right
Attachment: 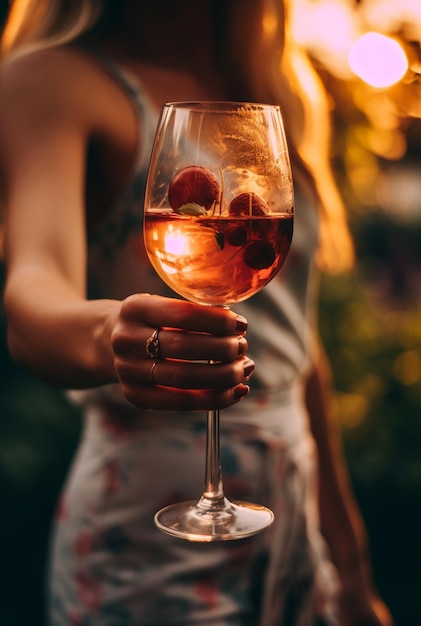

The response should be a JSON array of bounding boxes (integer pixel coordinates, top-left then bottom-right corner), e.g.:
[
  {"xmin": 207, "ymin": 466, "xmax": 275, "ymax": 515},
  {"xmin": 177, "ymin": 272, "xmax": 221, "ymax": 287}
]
[{"xmin": 1, "ymin": 0, "xmax": 354, "ymax": 272}]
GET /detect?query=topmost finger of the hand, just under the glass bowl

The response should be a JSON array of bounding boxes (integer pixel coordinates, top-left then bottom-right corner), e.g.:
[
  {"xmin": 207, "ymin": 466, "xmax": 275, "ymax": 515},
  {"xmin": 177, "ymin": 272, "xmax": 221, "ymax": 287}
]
[{"xmin": 122, "ymin": 294, "xmax": 247, "ymax": 336}]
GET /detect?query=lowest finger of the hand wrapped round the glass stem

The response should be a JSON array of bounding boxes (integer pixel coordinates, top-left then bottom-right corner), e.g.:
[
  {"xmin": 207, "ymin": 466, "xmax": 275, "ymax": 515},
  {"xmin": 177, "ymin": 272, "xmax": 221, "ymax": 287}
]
[{"xmin": 123, "ymin": 385, "xmax": 250, "ymax": 411}]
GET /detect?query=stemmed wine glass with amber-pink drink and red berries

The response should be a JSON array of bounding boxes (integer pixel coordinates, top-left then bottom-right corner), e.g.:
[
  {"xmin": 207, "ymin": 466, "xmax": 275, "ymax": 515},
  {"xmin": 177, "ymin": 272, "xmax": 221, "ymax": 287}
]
[{"xmin": 144, "ymin": 102, "xmax": 293, "ymax": 541}]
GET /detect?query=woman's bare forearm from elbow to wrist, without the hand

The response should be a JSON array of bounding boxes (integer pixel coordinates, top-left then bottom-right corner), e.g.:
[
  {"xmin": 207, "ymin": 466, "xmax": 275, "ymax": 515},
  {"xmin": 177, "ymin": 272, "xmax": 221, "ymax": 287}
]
[{"xmin": 4, "ymin": 268, "xmax": 120, "ymax": 388}]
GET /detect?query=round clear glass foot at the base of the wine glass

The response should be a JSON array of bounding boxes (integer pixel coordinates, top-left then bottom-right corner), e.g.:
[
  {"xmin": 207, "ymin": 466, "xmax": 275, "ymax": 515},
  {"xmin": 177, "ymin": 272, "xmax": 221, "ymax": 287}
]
[{"xmin": 154, "ymin": 497, "xmax": 274, "ymax": 542}]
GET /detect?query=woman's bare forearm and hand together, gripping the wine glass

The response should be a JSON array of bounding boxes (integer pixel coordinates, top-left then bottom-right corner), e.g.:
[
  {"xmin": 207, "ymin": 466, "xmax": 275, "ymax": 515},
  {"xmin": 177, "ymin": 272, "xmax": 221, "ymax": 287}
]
[{"xmin": 5, "ymin": 260, "xmax": 254, "ymax": 411}]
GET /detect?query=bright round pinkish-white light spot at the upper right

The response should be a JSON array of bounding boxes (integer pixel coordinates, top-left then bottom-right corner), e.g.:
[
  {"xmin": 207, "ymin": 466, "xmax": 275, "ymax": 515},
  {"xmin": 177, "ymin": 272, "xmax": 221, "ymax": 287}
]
[{"xmin": 348, "ymin": 32, "xmax": 408, "ymax": 88}]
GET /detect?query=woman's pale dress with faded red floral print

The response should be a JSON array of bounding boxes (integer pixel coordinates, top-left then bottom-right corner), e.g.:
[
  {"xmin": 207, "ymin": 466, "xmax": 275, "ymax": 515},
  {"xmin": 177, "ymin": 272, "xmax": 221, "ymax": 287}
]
[{"xmin": 49, "ymin": 52, "xmax": 337, "ymax": 626}]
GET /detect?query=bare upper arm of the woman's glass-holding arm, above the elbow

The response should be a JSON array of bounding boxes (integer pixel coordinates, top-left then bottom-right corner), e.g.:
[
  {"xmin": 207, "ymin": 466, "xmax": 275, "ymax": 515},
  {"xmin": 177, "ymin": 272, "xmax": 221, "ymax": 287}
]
[{"xmin": 0, "ymin": 53, "xmax": 90, "ymax": 293}]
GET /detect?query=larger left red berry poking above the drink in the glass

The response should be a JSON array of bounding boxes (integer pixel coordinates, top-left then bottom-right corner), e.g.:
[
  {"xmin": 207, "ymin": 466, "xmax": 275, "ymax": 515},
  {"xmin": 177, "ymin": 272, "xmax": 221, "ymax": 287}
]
[{"xmin": 168, "ymin": 165, "xmax": 220, "ymax": 211}]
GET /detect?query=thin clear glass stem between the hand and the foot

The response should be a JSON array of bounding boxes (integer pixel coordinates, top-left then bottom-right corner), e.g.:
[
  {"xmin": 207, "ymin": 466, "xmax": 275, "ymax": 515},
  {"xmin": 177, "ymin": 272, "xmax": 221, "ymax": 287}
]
[{"xmin": 202, "ymin": 410, "xmax": 224, "ymax": 504}]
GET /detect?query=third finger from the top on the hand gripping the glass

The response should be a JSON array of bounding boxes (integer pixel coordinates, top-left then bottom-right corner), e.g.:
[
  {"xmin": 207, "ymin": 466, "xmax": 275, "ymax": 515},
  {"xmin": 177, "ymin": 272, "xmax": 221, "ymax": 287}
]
[{"xmin": 116, "ymin": 356, "xmax": 254, "ymax": 390}]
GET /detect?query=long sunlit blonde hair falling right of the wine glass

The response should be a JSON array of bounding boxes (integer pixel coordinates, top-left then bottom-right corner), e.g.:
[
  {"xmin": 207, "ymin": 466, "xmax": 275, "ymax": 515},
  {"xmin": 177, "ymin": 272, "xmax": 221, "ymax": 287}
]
[{"xmin": 225, "ymin": 0, "xmax": 354, "ymax": 273}]
